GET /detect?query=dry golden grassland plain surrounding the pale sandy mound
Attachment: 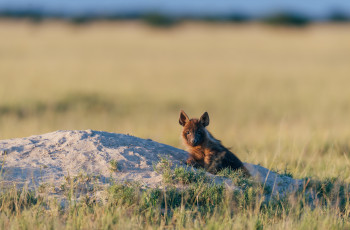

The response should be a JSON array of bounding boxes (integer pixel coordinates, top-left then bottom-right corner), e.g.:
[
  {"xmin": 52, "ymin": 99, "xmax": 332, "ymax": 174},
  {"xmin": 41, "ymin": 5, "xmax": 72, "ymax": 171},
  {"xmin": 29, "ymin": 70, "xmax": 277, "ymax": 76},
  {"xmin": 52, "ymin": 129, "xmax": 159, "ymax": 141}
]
[{"xmin": 0, "ymin": 21, "xmax": 350, "ymax": 229}]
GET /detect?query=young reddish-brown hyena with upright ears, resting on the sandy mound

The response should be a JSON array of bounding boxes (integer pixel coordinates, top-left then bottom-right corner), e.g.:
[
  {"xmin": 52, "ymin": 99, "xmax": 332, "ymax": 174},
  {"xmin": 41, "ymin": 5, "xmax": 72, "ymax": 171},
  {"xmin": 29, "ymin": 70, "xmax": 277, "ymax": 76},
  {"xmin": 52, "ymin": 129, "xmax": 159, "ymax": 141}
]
[{"xmin": 179, "ymin": 111, "xmax": 249, "ymax": 175}]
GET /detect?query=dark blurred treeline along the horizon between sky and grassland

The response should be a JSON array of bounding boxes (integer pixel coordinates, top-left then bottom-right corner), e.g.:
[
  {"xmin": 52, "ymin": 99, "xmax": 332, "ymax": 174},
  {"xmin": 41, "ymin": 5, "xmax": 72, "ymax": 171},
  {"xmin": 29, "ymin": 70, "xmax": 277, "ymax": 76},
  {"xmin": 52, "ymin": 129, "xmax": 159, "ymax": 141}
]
[{"xmin": 0, "ymin": 9, "xmax": 350, "ymax": 27}]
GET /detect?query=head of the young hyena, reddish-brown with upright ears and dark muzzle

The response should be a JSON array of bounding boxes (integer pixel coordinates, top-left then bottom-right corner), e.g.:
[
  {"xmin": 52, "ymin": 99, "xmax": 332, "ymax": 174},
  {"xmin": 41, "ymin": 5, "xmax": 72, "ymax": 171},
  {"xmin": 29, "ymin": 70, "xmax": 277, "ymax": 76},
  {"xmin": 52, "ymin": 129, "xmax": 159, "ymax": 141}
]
[{"xmin": 179, "ymin": 110, "xmax": 209, "ymax": 147}]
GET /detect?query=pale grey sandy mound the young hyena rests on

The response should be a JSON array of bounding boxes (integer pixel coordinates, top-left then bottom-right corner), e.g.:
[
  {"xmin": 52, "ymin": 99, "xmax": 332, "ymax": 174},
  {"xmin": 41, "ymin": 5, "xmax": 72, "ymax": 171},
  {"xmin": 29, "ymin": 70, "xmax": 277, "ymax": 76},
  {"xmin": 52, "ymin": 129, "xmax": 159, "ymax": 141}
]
[{"xmin": 0, "ymin": 130, "xmax": 302, "ymax": 194}]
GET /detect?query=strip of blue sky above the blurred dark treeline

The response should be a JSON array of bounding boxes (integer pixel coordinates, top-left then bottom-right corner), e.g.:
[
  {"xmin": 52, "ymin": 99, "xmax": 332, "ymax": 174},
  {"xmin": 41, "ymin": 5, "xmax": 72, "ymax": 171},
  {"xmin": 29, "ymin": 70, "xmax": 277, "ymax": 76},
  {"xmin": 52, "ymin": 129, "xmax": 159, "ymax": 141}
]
[{"xmin": 0, "ymin": 0, "xmax": 350, "ymax": 19}]
